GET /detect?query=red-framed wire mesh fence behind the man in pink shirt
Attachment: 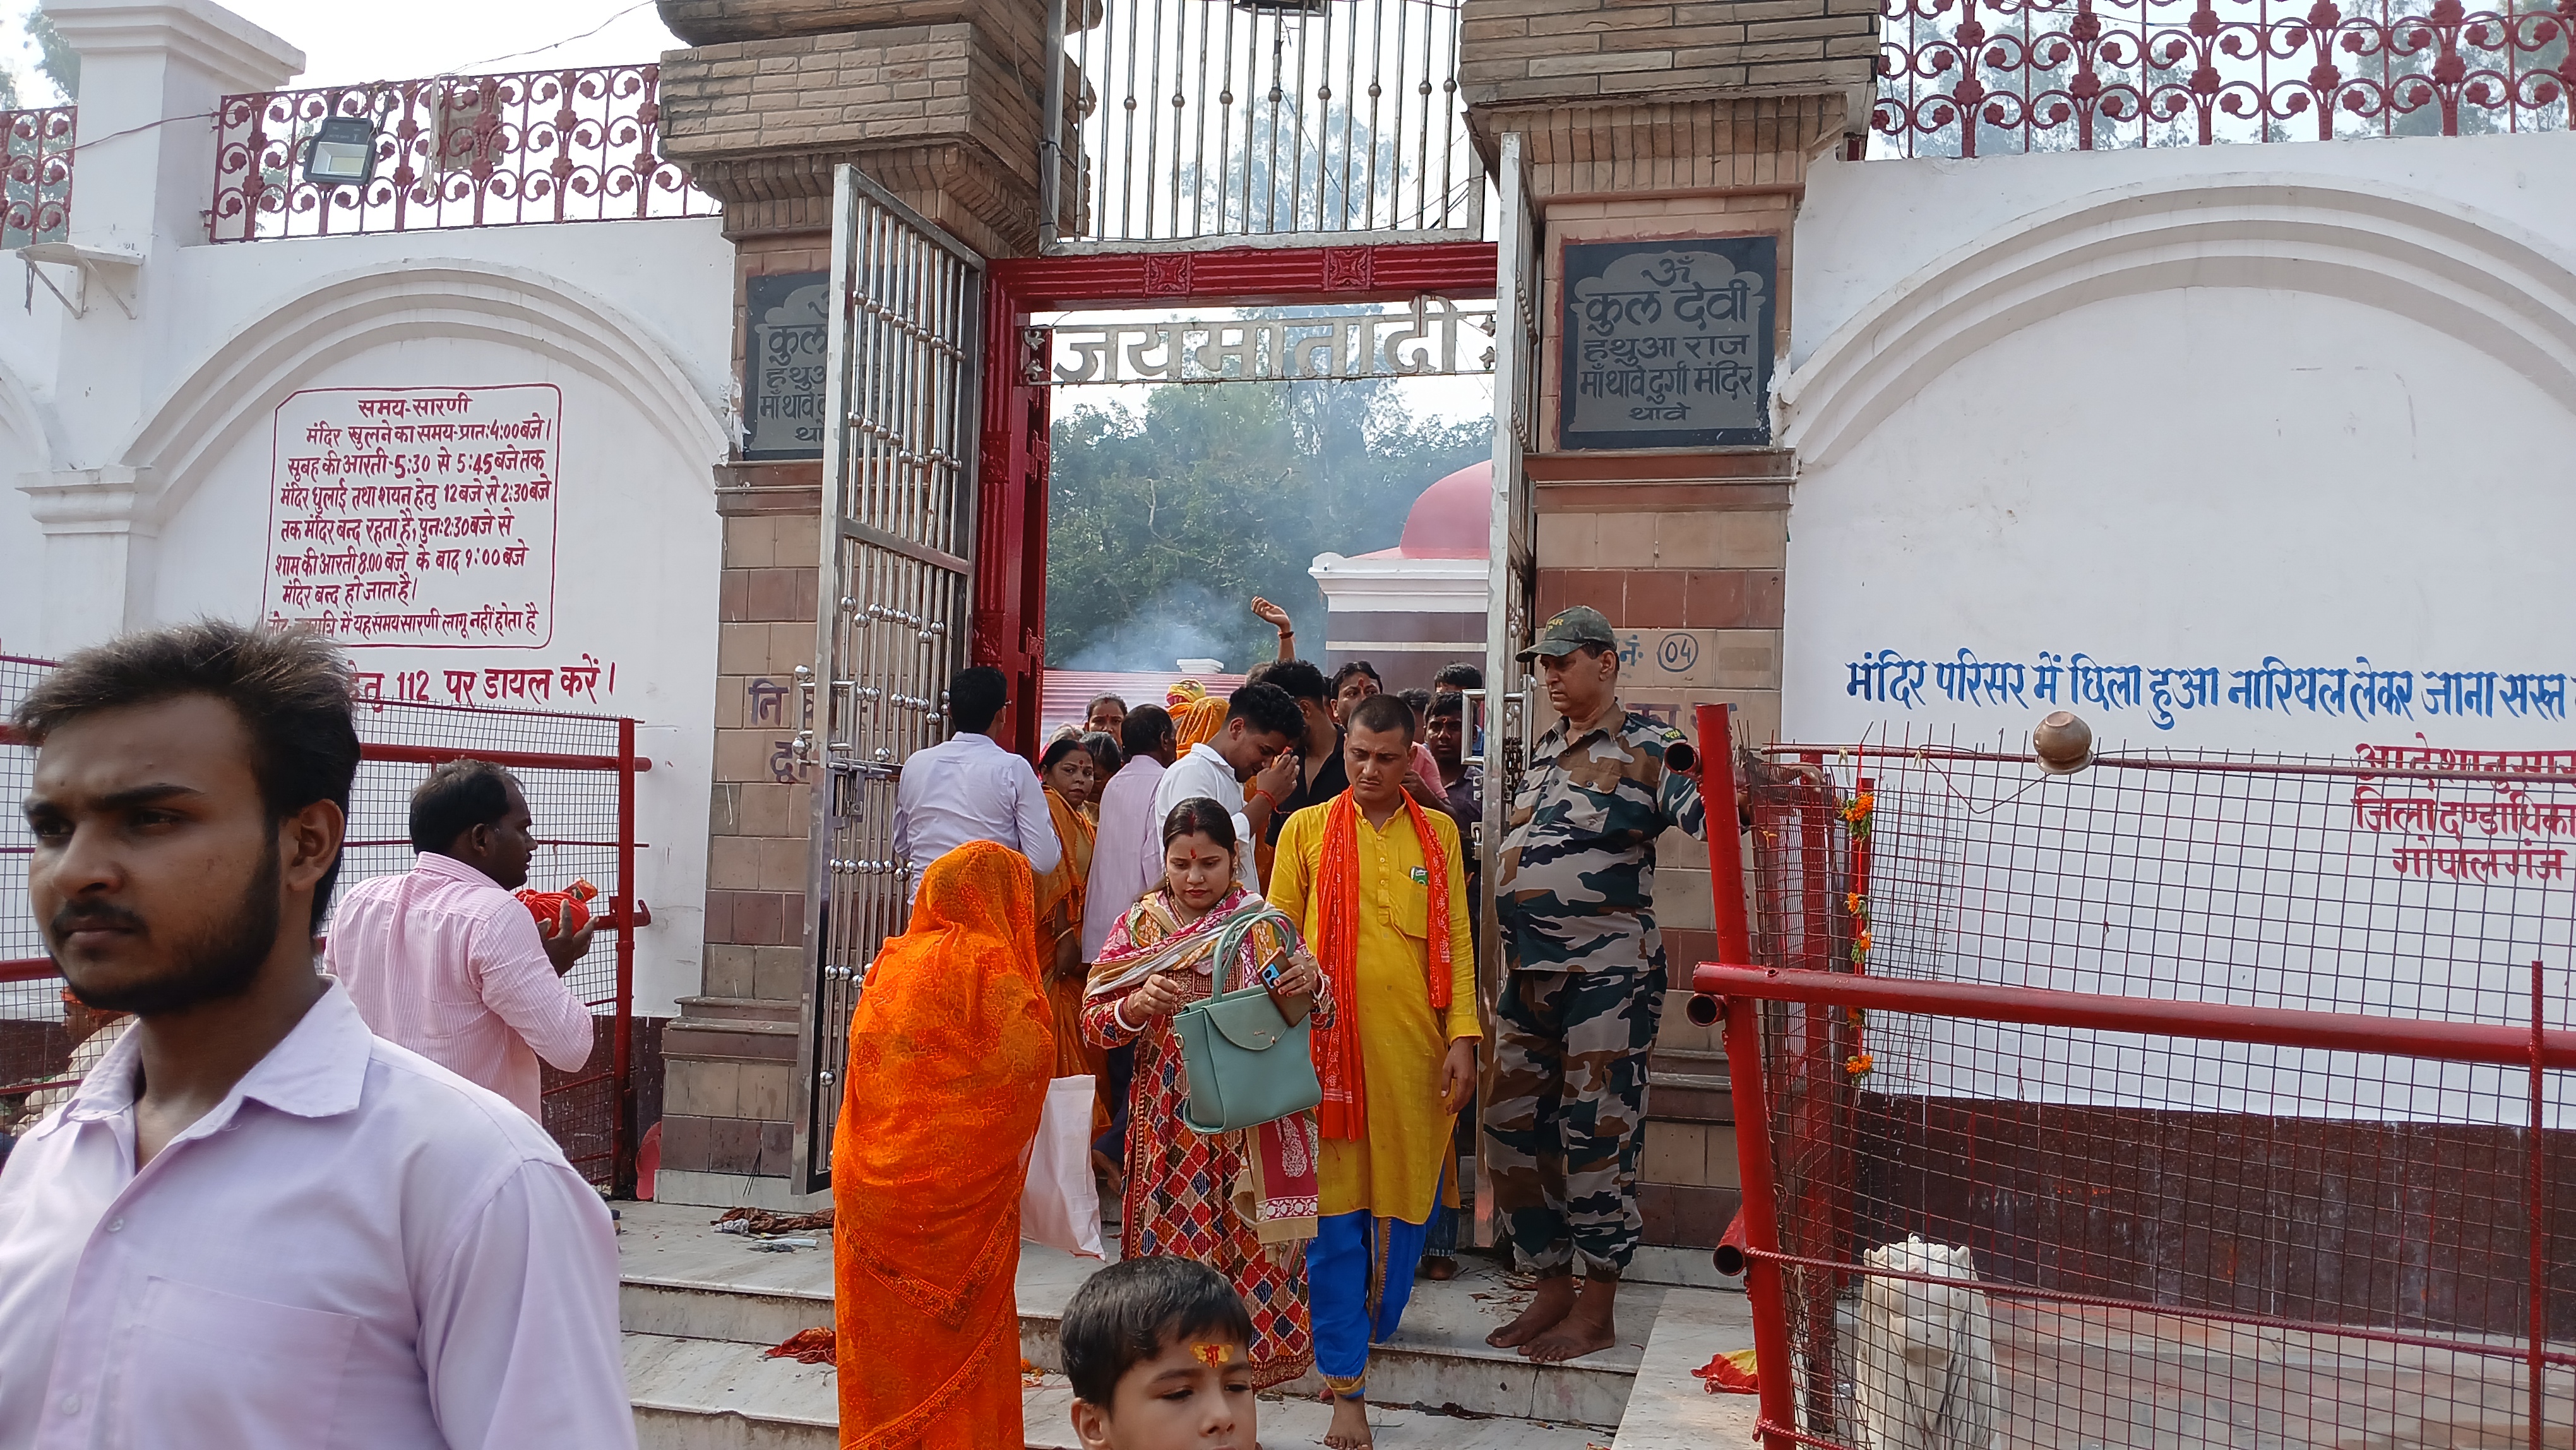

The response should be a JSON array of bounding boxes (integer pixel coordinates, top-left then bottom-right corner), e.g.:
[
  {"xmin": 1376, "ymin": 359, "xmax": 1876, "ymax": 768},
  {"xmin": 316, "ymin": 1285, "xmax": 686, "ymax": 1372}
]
[{"xmin": 0, "ymin": 657, "xmax": 641, "ymax": 1187}]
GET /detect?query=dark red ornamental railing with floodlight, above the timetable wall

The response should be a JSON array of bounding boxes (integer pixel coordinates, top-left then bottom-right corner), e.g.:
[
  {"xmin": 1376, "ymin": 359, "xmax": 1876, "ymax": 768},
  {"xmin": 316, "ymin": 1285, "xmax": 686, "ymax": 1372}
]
[{"xmin": 206, "ymin": 64, "xmax": 719, "ymax": 242}]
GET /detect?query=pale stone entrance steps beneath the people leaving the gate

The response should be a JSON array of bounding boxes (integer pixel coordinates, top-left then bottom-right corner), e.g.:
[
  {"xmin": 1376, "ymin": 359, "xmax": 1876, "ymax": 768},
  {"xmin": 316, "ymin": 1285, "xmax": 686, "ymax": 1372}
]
[{"xmin": 618, "ymin": 1202, "xmax": 1669, "ymax": 1427}]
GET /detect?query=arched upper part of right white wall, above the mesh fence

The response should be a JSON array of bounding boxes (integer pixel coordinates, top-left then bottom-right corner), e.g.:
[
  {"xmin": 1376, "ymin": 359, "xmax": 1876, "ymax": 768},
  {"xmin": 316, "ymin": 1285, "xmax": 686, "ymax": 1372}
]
[{"xmin": 1780, "ymin": 136, "xmax": 2576, "ymax": 755}]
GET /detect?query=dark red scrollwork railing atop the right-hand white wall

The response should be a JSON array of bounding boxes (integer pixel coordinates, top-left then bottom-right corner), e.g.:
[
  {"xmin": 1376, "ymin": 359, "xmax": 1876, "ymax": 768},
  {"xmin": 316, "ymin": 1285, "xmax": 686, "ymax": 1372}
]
[{"xmin": 1870, "ymin": 0, "xmax": 2576, "ymax": 157}]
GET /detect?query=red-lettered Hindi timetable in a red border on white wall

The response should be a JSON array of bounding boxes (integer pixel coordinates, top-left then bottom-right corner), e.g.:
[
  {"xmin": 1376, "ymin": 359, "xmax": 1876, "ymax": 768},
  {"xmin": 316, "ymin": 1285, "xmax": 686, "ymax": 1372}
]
[{"xmin": 260, "ymin": 384, "xmax": 564, "ymax": 649}]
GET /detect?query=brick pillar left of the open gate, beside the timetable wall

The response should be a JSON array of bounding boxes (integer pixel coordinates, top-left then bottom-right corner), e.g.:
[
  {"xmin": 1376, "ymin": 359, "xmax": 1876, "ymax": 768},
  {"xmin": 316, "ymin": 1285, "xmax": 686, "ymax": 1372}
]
[{"xmin": 659, "ymin": 0, "xmax": 1046, "ymax": 1208}]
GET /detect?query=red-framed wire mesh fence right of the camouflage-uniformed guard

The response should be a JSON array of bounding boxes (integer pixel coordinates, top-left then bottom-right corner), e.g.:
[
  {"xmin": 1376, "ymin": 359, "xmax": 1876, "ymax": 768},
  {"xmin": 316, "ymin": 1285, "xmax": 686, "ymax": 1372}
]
[{"xmin": 1703, "ymin": 742, "xmax": 2576, "ymax": 1450}]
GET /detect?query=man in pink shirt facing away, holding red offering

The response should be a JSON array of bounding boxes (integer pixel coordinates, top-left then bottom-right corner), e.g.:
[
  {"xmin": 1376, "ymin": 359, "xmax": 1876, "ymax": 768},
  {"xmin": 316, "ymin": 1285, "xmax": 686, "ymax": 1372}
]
[{"xmin": 322, "ymin": 760, "xmax": 590, "ymax": 1123}]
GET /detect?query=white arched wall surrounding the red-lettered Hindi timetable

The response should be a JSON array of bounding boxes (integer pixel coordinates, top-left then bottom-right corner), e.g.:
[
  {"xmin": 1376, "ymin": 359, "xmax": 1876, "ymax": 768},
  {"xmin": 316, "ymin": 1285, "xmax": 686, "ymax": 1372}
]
[{"xmin": 0, "ymin": 0, "xmax": 732, "ymax": 1015}]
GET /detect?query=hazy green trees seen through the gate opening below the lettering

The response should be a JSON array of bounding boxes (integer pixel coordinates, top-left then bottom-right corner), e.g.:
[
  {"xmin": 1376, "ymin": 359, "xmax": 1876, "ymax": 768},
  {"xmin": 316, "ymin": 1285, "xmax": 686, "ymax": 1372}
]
[{"xmin": 1046, "ymin": 381, "xmax": 1491, "ymax": 669}]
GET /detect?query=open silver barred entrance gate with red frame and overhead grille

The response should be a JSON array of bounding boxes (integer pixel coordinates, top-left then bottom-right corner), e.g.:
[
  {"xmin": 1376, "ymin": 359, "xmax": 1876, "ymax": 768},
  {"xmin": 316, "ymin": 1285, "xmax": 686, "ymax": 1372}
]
[{"xmin": 791, "ymin": 0, "xmax": 1538, "ymax": 1205}]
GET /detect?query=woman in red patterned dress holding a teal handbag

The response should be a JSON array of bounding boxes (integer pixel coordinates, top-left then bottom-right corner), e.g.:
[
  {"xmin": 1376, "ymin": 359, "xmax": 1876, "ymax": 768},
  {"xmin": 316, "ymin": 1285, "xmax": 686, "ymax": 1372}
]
[{"xmin": 1082, "ymin": 798, "xmax": 1332, "ymax": 1388}]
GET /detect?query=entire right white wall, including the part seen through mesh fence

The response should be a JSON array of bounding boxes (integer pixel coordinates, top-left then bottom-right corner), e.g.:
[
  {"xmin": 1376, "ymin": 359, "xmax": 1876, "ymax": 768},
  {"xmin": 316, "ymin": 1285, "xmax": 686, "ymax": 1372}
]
[{"xmin": 1775, "ymin": 134, "xmax": 2576, "ymax": 1123}]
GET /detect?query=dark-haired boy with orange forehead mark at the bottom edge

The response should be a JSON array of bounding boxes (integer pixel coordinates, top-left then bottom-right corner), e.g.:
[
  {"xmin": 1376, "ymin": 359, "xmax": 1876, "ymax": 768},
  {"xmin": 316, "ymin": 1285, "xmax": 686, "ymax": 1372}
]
[{"xmin": 1059, "ymin": 1257, "xmax": 1255, "ymax": 1450}]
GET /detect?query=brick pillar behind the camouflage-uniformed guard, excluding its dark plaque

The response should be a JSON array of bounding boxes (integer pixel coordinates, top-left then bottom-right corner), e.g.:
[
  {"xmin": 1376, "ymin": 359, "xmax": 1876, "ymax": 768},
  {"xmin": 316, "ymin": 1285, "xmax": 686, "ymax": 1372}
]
[{"xmin": 1458, "ymin": 0, "xmax": 1878, "ymax": 1247}]
